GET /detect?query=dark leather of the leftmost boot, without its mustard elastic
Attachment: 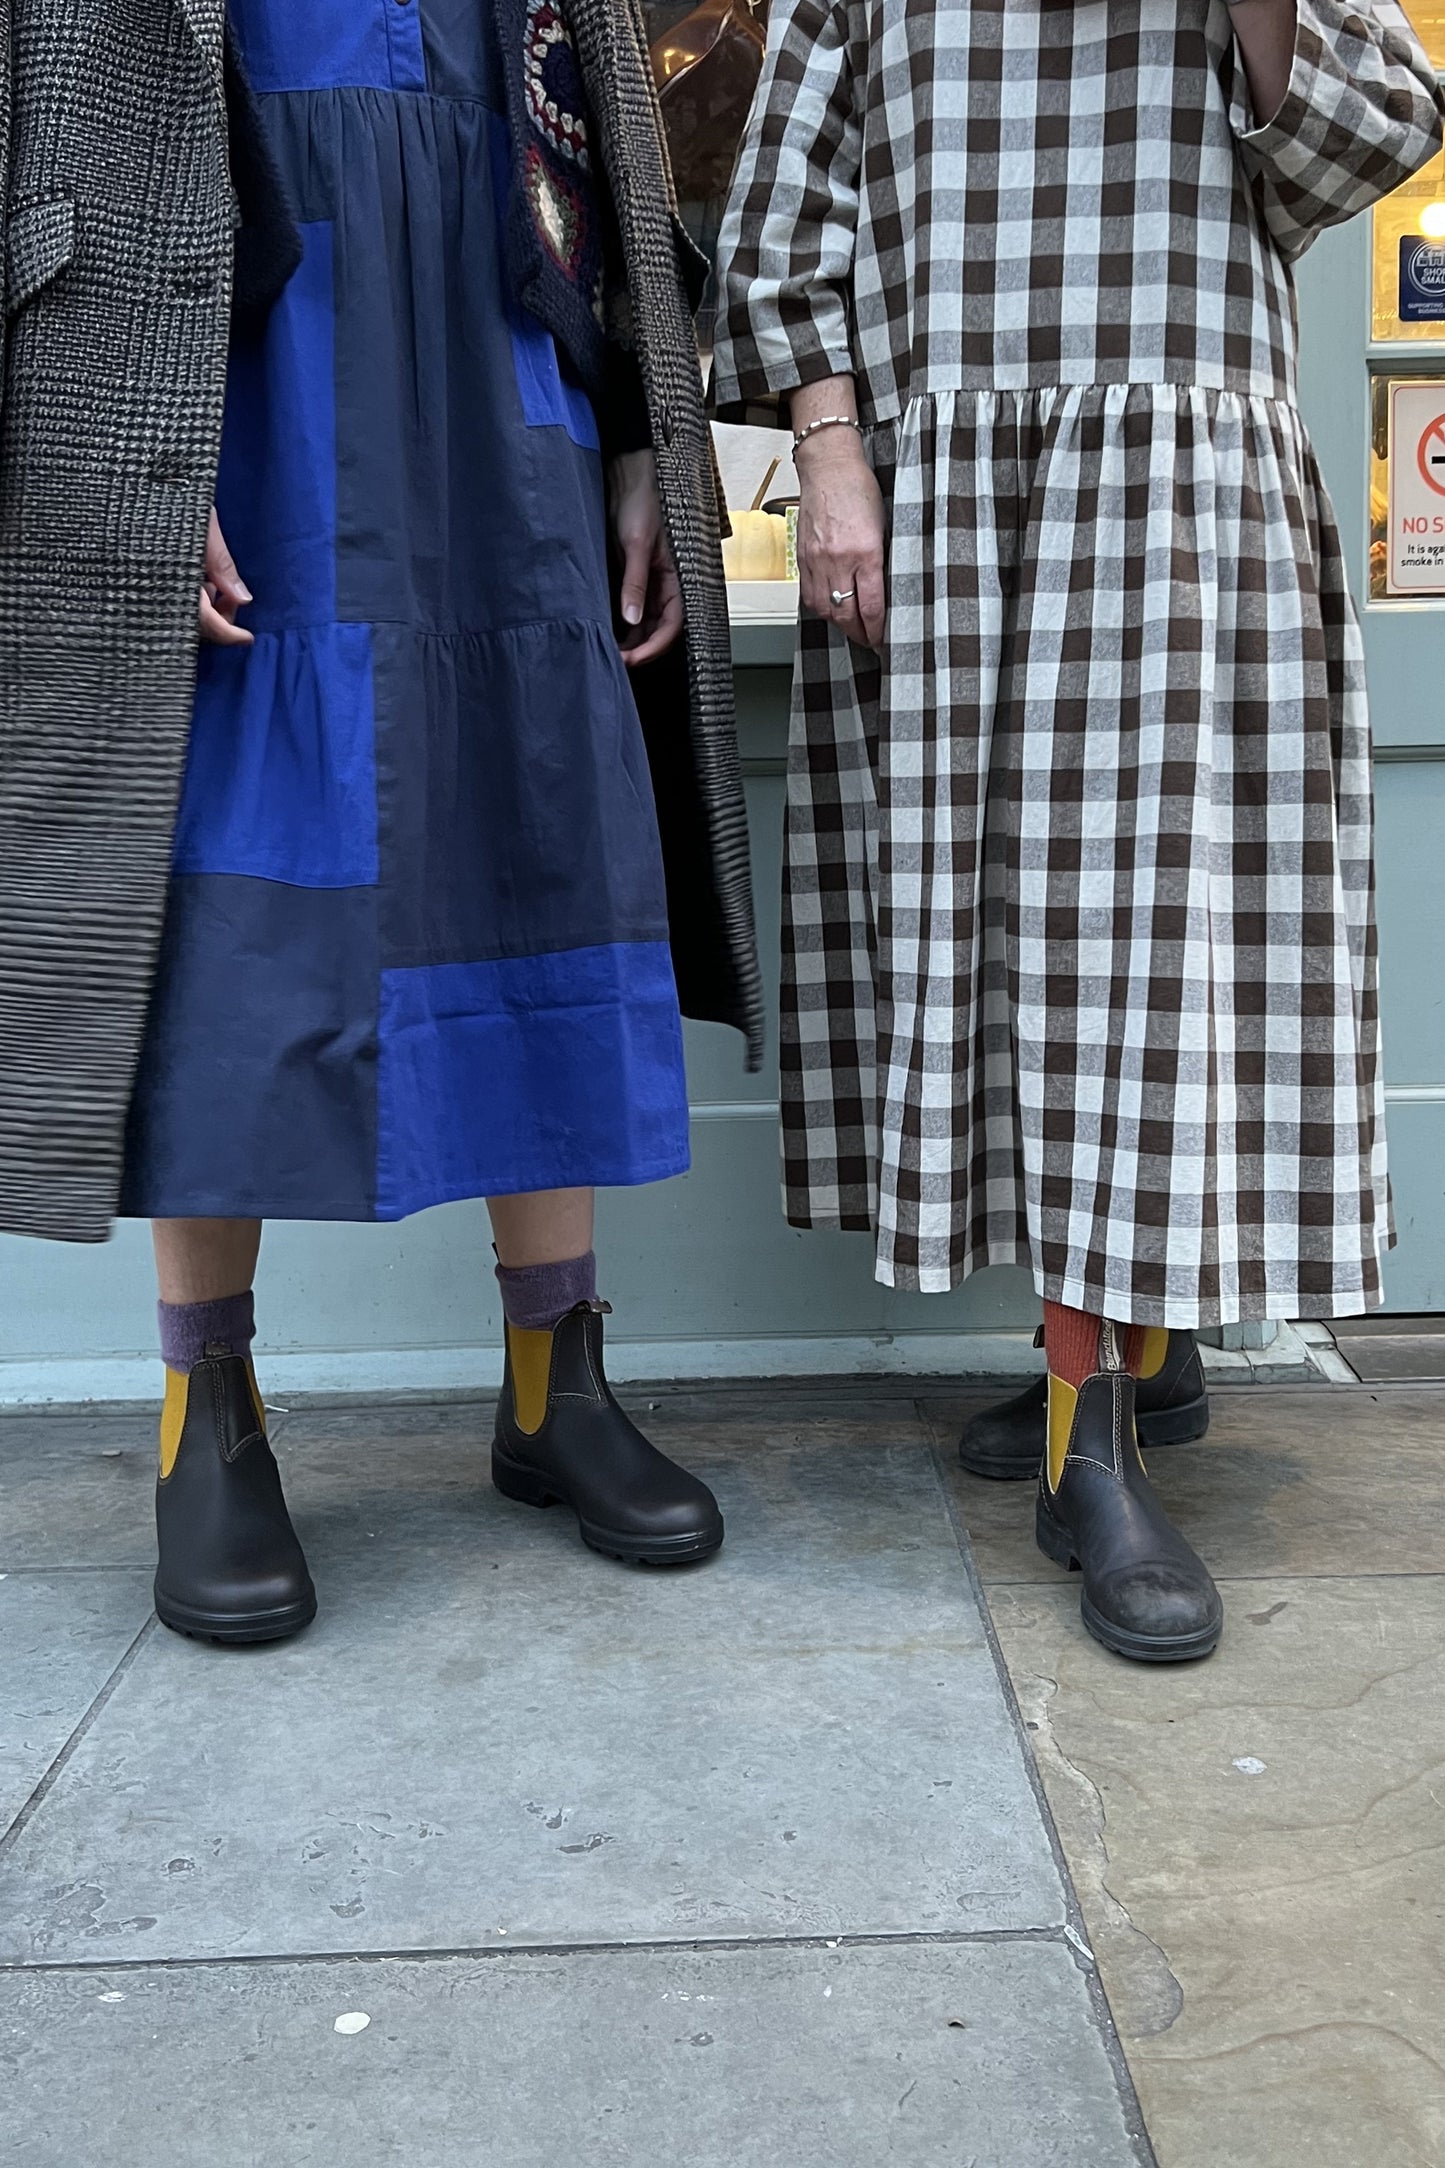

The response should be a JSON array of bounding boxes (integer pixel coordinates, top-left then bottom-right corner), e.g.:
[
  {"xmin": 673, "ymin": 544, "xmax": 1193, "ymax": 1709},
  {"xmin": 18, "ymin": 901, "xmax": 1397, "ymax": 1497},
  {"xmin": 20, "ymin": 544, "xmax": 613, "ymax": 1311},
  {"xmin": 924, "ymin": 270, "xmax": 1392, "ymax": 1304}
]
[{"xmin": 156, "ymin": 1355, "xmax": 316, "ymax": 1641}]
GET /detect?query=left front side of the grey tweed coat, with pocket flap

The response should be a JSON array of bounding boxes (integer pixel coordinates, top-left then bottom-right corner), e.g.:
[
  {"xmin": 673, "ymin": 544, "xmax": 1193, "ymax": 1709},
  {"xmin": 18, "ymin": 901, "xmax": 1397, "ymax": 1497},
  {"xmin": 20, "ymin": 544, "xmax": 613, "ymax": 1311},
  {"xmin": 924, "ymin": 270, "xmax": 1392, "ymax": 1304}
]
[{"xmin": 0, "ymin": 0, "xmax": 232, "ymax": 1240}]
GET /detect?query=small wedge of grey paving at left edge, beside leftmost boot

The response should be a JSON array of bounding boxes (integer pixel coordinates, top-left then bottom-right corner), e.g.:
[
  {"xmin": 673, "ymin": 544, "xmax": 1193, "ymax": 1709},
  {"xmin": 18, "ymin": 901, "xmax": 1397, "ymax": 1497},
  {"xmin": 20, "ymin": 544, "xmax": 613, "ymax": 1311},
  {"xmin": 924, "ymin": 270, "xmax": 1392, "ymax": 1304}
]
[{"xmin": 0, "ymin": 1570, "xmax": 149, "ymax": 1836}]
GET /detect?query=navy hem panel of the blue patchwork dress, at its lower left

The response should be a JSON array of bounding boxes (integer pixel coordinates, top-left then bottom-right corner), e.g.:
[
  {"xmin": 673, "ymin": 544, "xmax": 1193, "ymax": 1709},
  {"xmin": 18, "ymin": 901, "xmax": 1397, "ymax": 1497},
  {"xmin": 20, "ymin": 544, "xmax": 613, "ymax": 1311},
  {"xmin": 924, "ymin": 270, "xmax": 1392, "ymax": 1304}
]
[{"xmin": 121, "ymin": 876, "xmax": 379, "ymax": 1218}]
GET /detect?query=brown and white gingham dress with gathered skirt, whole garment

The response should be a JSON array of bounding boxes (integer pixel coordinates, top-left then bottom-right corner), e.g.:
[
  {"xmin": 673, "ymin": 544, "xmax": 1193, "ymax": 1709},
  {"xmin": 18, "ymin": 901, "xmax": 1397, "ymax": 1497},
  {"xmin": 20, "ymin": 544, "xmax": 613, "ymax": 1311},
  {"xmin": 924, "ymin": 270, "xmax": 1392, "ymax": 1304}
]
[{"xmin": 715, "ymin": 0, "xmax": 1441, "ymax": 1327}]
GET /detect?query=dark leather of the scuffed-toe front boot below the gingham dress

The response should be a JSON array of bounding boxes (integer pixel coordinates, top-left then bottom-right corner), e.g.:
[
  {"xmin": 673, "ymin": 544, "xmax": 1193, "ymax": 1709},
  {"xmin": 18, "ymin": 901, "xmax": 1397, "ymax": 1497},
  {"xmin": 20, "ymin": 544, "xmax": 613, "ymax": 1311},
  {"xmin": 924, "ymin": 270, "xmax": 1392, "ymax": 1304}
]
[{"xmin": 1038, "ymin": 1370, "xmax": 1224, "ymax": 1663}]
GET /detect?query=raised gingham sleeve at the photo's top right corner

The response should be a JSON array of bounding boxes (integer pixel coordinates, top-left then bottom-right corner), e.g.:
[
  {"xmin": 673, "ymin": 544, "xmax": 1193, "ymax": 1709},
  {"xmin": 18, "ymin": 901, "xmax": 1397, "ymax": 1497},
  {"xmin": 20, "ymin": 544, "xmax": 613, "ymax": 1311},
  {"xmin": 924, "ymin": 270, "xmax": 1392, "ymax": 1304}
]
[{"xmin": 1231, "ymin": 0, "xmax": 1441, "ymax": 260}]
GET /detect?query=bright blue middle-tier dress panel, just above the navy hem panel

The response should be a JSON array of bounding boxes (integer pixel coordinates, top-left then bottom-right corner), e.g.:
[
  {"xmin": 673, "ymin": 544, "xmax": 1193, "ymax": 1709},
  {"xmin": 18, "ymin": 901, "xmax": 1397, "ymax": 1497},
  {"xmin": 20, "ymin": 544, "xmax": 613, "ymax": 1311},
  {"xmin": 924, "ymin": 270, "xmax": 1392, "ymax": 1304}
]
[{"xmin": 175, "ymin": 624, "xmax": 377, "ymax": 889}]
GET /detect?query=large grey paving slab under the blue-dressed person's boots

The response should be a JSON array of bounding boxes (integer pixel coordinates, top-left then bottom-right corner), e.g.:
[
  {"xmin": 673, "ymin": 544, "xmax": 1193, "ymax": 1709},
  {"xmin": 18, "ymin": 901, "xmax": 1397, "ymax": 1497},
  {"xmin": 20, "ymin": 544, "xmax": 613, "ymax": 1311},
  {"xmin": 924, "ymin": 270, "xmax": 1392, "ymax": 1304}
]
[{"xmin": 0, "ymin": 1439, "xmax": 1064, "ymax": 1962}]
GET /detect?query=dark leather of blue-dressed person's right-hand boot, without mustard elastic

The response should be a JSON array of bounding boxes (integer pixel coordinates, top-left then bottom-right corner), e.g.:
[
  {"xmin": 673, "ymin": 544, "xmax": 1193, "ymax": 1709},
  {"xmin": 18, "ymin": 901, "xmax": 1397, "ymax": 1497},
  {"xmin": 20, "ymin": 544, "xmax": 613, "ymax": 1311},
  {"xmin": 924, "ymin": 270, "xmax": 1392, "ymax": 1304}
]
[{"xmin": 492, "ymin": 1303, "xmax": 724, "ymax": 1565}]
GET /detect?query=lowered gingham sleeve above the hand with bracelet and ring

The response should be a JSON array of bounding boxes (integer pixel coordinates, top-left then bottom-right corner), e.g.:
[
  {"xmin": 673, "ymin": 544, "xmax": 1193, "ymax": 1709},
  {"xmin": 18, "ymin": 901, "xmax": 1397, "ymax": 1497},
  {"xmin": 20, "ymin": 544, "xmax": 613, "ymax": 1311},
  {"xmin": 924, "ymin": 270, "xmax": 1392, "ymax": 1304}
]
[{"xmin": 713, "ymin": 0, "xmax": 867, "ymax": 412}]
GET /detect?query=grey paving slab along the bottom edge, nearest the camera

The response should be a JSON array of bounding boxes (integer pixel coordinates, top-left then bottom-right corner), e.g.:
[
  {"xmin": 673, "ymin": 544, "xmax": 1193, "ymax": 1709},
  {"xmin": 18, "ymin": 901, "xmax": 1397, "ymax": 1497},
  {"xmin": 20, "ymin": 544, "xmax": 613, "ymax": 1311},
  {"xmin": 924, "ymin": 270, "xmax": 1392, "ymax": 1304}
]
[{"xmin": 0, "ymin": 1943, "xmax": 1137, "ymax": 2168}]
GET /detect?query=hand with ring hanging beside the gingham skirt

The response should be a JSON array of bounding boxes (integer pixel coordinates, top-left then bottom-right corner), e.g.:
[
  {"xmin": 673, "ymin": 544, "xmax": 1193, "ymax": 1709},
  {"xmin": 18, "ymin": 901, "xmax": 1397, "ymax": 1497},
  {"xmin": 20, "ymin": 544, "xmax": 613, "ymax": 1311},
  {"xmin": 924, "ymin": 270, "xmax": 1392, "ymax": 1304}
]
[{"xmin": 797, "ymin": 429, "xmax": 888, "ymax": 648}]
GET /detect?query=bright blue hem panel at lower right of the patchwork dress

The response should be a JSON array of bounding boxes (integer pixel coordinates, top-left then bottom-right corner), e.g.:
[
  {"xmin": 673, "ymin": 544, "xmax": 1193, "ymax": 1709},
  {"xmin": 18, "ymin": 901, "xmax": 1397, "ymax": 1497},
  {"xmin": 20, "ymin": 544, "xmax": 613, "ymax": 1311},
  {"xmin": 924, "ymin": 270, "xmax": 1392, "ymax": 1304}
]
[{"xmin": 377, "ymin": 943, "xmax": 689, "ymax": 1218}]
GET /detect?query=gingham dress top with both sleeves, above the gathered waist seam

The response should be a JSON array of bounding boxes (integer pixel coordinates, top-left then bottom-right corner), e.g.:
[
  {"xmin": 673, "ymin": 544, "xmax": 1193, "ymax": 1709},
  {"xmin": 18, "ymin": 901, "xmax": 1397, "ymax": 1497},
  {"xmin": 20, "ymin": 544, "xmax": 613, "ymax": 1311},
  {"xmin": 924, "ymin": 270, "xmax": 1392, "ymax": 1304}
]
[{"xmin": 715, "ymin": 0, "xmax": 1441, "ymax": 418}]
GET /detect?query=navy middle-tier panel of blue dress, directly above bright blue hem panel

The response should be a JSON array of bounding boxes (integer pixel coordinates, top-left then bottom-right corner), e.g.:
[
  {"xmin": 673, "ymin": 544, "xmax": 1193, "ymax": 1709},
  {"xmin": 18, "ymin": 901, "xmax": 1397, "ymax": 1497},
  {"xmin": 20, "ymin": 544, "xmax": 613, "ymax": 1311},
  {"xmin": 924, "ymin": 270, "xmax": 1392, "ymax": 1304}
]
[{"xmin": 375, "ymin": 620, "xmax": 667, "ymax": 965}]
